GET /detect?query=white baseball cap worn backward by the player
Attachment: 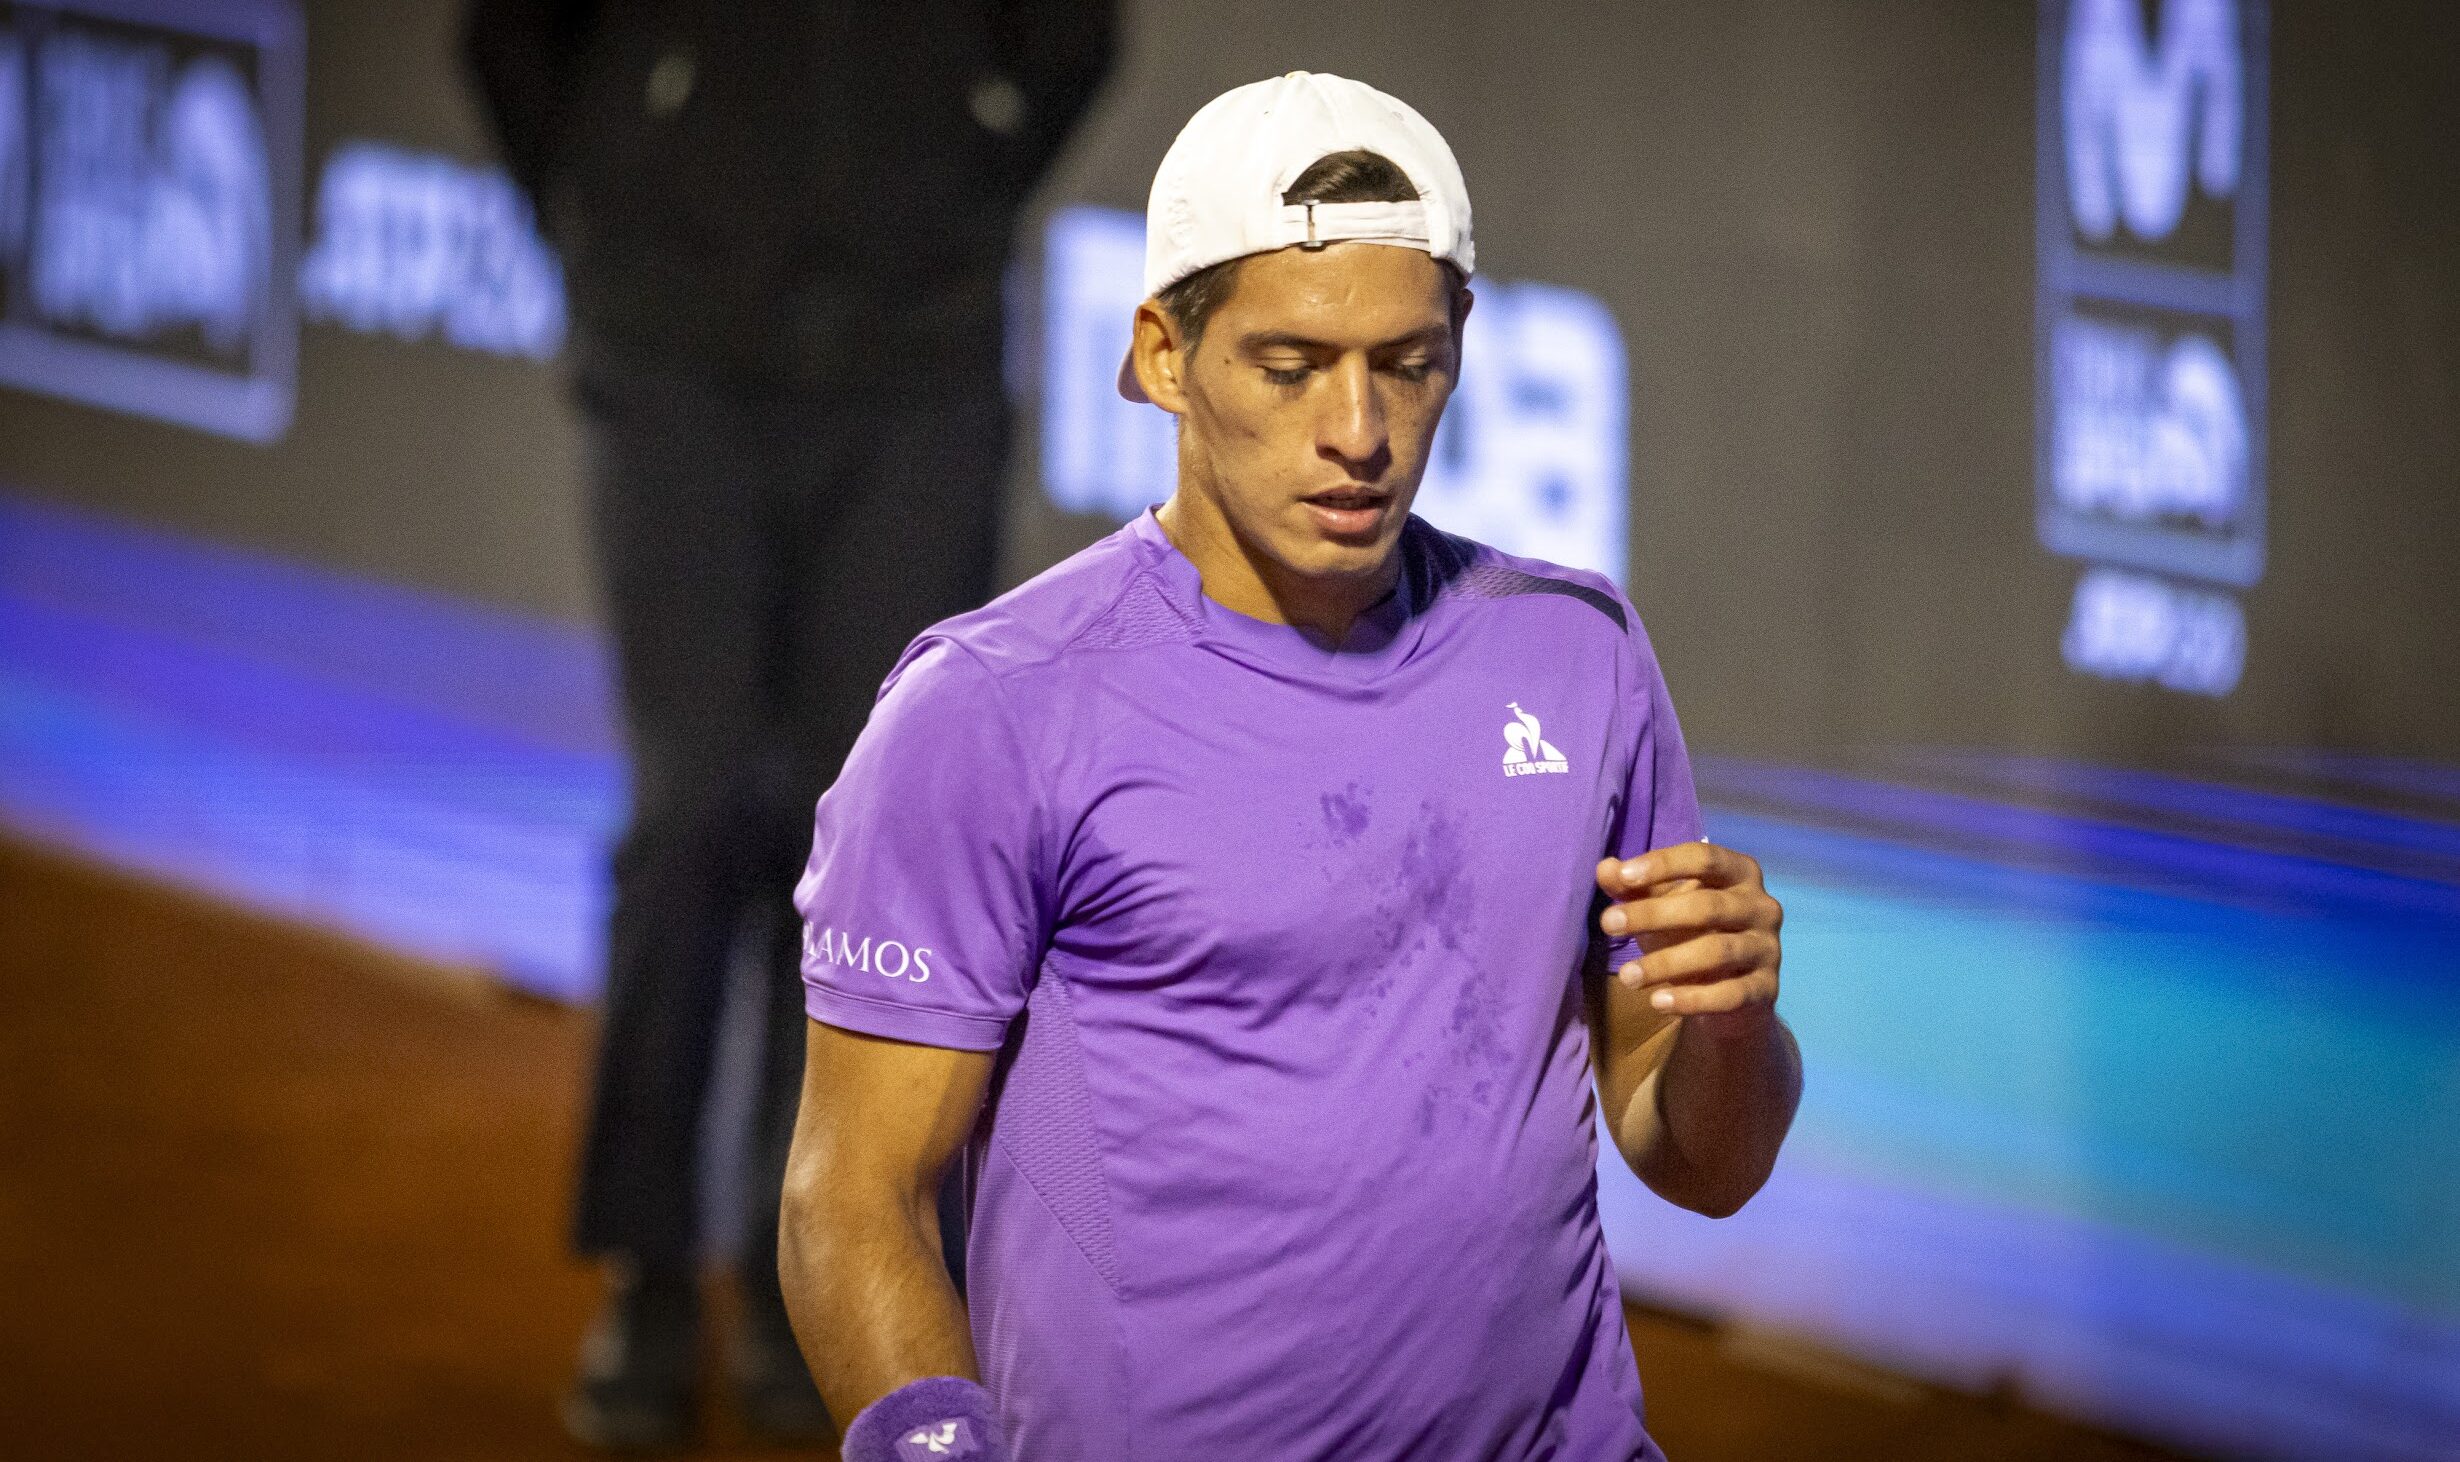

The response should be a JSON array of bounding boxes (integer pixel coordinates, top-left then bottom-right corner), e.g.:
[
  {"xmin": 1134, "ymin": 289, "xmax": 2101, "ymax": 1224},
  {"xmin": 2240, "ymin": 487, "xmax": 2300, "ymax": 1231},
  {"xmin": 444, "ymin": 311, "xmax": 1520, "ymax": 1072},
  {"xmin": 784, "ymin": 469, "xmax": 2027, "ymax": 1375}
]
[{"xmin": 1119, "ymin": 71, "xmax": 1476, "ymax": 401}]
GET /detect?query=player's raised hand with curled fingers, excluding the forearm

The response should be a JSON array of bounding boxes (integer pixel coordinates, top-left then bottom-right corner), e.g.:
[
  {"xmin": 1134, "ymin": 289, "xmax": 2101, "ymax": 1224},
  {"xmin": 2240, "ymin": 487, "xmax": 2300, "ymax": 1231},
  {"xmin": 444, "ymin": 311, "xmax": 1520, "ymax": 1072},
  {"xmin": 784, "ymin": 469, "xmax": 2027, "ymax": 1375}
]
[{"xmin": 1597, "ymin": 839, "xmax": 1786, "ymax": 1036}]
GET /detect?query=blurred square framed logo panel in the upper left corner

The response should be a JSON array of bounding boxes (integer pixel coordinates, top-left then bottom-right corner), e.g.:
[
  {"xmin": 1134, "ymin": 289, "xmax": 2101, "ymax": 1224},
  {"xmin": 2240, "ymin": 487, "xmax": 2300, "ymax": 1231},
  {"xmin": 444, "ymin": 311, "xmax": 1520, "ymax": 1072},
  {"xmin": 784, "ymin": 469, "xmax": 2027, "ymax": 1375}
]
[{"xmin": 0, "ymin": 0, "xmax": 303, "ymax": 441}]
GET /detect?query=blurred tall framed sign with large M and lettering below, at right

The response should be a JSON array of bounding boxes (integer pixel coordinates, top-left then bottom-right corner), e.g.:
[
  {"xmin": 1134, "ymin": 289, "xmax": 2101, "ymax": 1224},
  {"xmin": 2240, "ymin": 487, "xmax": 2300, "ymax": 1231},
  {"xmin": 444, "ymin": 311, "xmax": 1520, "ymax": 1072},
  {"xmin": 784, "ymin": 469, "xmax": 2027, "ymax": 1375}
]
[{"xmin": 2037, "ymin": 0, "xmax": 2266, "ymax": 697}]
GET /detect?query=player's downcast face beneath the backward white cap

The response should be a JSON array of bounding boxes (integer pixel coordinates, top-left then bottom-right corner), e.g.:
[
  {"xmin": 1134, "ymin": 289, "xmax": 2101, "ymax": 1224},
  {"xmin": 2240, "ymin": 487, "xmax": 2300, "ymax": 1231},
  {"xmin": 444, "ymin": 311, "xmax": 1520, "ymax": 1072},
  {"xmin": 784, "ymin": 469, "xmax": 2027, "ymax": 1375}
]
[{"xmin": 1181, "ymin": 244, "xmax": 1469, "ymax": 578}]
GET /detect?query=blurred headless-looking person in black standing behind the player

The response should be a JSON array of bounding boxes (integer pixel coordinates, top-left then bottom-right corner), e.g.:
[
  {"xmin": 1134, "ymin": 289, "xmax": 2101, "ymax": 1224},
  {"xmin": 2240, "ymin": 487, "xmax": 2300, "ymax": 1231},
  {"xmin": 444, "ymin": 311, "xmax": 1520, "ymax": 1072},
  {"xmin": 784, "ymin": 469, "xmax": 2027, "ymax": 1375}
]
[{"xmin": 462, "ymin": 0, "xmax": 1114, "ymax": 1447}]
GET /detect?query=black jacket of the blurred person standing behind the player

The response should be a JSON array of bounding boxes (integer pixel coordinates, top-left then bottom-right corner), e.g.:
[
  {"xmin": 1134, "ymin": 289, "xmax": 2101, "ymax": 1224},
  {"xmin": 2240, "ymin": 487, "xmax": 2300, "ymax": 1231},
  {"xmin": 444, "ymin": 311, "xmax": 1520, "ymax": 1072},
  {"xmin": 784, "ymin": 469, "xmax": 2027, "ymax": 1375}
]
[{"xmin": 462, "ymin": 0, "xmax": 1114, "ymax": 386}]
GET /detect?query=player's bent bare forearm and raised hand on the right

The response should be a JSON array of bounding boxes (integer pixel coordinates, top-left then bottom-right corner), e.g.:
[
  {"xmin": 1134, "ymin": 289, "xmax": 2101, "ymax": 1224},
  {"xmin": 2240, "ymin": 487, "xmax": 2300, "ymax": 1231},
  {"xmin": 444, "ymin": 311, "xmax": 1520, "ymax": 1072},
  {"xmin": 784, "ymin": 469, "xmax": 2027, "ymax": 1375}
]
[{"xmin": 1587, "ymin": 842, "xmax": 1803, "ymax": 1218}]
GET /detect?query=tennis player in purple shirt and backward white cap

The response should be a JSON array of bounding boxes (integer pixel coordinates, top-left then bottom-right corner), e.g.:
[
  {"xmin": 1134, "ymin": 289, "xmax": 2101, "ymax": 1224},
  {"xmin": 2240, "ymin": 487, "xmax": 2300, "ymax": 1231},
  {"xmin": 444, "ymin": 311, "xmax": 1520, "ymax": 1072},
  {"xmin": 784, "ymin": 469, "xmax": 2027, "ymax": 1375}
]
[{"xmin": 782, "ymin": 71, "xmax": 1801, "ymax": 1462}]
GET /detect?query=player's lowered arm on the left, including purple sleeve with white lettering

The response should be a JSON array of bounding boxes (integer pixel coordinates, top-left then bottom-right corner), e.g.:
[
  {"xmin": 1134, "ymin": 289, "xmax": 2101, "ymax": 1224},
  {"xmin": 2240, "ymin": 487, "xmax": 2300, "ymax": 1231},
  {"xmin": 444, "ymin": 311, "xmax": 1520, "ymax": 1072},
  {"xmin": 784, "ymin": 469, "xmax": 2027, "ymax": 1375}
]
[{"xmin": 777, "ymin": 635, "xmax": 1053, "ymax": 1460}]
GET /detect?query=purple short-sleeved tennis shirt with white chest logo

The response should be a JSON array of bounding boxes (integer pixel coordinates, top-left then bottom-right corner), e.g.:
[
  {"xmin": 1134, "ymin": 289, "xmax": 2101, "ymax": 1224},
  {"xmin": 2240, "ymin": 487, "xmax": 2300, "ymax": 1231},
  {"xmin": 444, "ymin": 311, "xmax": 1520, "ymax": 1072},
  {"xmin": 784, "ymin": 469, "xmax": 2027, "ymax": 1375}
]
[{"xmin": 797, "ymin": 514, "xmax": 1700, "ymax": 1462}]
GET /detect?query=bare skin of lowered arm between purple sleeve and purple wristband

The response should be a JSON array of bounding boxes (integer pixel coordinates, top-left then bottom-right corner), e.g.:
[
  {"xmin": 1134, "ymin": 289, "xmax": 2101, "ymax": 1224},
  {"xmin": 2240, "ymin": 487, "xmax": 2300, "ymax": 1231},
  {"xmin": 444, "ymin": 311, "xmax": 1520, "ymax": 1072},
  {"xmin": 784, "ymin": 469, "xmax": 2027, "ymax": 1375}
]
[{"xmin": 777, "ymin": 1021, "xmax": 994, "ymax": 1423}]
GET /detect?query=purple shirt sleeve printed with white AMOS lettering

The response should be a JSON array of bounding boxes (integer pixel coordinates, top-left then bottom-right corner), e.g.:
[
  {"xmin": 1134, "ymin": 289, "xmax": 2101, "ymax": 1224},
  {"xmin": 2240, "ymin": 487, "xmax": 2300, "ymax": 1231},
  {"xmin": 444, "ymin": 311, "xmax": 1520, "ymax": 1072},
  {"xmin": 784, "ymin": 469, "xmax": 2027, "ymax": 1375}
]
[{"xmin": 795, "ymin": 640, "xmax": 1048, "ymax": 1051}]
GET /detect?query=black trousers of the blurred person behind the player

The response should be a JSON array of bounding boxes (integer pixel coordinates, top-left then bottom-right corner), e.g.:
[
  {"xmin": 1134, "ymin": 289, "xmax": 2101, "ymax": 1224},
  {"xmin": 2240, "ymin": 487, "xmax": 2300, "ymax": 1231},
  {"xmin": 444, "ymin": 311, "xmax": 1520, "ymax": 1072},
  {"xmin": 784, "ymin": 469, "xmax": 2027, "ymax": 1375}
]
[{"xmin": 573, "ymin": 361, "xmax": 1009, "ymax": 1302}]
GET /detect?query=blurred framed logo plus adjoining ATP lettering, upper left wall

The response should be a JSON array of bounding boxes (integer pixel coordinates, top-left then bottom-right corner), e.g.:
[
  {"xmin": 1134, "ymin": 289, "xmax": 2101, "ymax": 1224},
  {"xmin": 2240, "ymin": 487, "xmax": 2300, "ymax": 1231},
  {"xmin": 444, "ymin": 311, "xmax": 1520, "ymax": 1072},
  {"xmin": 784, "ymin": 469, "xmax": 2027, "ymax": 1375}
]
[{"xmin": 0, "ymin": 0, "xmax": 563, "ymax": 443}]
